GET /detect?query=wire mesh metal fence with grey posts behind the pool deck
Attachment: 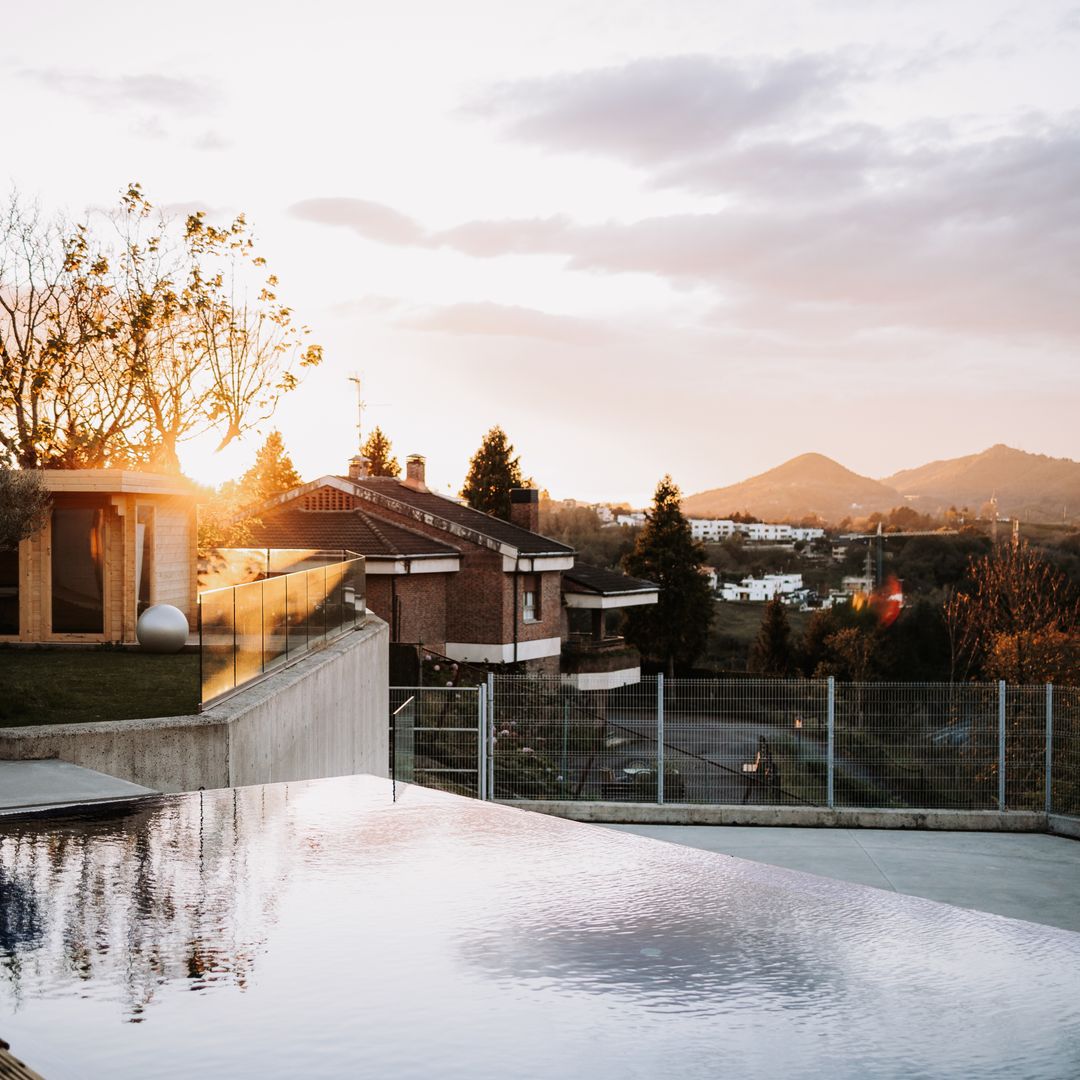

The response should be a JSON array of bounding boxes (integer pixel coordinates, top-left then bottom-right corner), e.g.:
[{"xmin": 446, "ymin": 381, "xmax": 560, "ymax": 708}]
[{"xmin": 392, "ymin": 675, "xmax": 1080, "ymax": 815}]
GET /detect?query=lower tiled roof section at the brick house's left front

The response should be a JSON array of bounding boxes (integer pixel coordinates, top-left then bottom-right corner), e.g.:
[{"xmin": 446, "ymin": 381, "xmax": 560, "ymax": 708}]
[{"xmin": 243, "ymin": 505, "xmax": 460, "ymax": 558}]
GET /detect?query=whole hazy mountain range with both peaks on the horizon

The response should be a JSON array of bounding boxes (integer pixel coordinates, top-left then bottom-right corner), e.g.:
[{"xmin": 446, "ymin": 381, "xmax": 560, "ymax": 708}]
[{"xmin": 683, "ymin": 444, "xmax": 1080, "ymax": 523}]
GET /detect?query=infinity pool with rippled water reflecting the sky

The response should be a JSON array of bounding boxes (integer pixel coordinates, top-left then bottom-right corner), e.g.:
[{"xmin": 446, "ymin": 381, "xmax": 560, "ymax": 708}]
[{"xmin": 0, "ymin": 777, "xmax": 1080, "ymax": 1080}]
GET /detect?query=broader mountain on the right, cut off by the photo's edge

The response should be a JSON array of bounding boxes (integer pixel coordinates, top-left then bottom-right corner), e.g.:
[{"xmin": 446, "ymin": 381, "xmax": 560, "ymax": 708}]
[{"xmin": 882, "ymin": 443, "xmax": 1080, "ymax": 522}]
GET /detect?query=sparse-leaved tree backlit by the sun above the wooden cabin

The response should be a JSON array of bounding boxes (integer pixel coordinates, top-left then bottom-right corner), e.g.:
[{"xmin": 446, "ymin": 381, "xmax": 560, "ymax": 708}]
[{"xmin": 0, "ymin": 185, "xmax": 322, "ymax": 470}]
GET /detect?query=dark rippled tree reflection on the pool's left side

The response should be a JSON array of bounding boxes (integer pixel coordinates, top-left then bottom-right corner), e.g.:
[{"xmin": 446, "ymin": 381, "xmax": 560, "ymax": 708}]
[{"xmin": 0, "ymin": 786, "xmax": 287, "ymax": 1022}]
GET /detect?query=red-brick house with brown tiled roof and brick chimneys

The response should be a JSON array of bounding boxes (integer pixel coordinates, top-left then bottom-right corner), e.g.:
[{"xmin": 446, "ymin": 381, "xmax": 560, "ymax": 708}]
[{"xmin": 234, "ymin": 455, "xmax": 657, "ymax": 681}]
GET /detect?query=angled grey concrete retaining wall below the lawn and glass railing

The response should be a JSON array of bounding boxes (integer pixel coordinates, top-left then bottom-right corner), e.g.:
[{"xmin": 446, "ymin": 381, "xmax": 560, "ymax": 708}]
[{"xmin": 0, "ymin": 616, "xmax": 389, "ymax": 792}]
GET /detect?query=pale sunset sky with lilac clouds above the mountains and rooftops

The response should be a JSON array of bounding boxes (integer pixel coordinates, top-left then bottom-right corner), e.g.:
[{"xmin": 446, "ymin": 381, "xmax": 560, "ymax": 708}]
[{"xmin": 0, "ymin": 0, "xmax": 1080, "ymax": 504}]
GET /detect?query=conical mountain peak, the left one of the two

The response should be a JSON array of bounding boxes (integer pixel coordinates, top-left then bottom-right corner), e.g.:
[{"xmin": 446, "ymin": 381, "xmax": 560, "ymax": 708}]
[{"xmin": 683, "ymin": 454, "xmax": 904, "ymax": 523}]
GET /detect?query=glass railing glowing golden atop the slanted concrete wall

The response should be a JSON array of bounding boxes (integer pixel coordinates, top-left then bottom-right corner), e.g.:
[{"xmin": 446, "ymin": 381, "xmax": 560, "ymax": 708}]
[{"xmin": 199, "ymin": 556, "xmax": 366, "ymax": 706}]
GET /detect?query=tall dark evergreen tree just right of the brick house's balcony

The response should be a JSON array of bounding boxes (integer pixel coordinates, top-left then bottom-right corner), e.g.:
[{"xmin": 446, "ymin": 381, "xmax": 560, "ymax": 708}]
[{"xmin": 623, "ymin": 476, "xmax": 713, "ymax": 675}]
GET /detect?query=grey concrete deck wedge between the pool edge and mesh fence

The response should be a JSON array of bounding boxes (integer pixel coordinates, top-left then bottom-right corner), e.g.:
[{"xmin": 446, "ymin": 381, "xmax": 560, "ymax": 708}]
[{"xmin": 603, "ymin": 825, "xmax": 1080, "ymax": 932}]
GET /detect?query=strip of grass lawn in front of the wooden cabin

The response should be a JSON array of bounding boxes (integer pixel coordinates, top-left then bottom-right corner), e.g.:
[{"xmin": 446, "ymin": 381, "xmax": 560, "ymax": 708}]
[{"xmin": 0, "ymin": 648, "xmax": 199, "ymax": 728}]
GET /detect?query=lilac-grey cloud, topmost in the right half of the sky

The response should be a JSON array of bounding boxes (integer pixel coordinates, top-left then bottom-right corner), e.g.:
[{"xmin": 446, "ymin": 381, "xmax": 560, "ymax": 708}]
[{"xmin": 469, "ymin": 55, "xmax": 856, "ymax": 164}]
